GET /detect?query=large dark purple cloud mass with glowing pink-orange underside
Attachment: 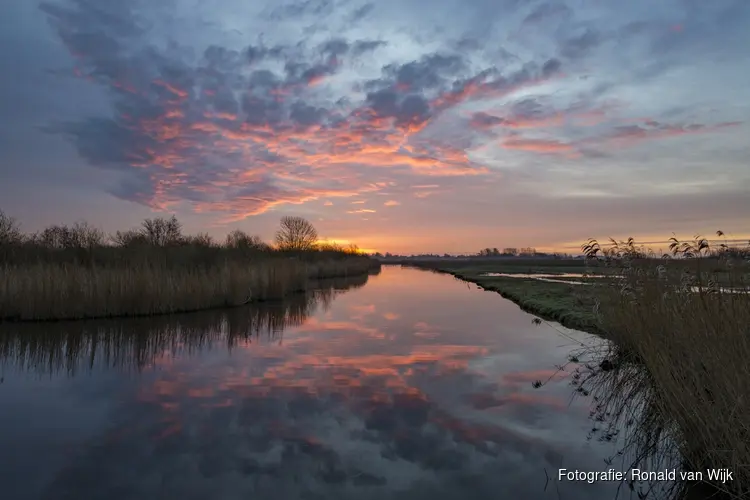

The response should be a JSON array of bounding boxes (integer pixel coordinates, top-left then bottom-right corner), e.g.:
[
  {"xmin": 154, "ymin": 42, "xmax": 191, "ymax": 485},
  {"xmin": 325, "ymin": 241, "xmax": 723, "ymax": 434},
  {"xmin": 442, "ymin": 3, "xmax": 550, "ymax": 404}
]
[{"xmin": 38, "ymin": 3, "xmax": 508, "ymax": 219}]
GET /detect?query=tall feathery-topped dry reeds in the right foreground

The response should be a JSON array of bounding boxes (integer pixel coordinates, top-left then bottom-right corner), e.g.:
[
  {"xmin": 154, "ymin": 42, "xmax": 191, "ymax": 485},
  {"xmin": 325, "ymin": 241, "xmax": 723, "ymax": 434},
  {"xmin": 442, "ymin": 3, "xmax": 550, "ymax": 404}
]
[{"xmin": 574, "ymin": 233, "xmax": 750, "ymax": 498}]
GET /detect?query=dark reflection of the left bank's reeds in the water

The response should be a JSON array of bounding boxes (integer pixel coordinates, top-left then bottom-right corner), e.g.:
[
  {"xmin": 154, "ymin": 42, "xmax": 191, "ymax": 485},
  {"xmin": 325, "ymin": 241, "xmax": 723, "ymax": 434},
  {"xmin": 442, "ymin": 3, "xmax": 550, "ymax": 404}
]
[{"xmin": 0, "ymin": 275, "xmax": 367, "ymax": 375}]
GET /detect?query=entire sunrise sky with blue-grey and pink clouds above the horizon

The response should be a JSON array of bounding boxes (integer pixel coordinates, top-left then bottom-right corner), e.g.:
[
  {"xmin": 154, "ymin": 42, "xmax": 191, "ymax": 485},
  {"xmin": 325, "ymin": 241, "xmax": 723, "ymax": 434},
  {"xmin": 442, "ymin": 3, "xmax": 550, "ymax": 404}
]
[{"xmin": 0, "ymin": 0, "xmax": 750, "ymax": 253}]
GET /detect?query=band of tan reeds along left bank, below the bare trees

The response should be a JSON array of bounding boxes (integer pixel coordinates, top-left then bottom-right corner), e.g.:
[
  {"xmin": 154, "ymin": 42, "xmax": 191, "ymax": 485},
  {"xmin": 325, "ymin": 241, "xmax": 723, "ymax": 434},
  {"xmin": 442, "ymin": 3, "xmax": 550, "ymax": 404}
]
[{"xmin": 0, "ymin": 255, "xmax": 379, "ymax": 321}]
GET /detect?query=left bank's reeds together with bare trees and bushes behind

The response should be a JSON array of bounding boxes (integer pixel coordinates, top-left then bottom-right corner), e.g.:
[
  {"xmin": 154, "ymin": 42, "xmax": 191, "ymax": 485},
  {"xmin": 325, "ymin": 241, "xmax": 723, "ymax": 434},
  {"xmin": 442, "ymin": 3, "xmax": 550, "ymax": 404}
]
[{"xmin": 0, "ymin": 212, "xmax": 379, "ymax": 320}]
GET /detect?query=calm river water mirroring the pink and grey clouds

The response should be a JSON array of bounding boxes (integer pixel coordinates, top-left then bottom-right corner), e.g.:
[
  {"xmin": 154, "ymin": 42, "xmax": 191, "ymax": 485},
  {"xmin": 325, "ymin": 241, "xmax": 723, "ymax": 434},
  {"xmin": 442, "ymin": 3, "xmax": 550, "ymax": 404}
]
[{"xmin": 0, "ymin": 267, "xmax": 617, "ymax": 500}]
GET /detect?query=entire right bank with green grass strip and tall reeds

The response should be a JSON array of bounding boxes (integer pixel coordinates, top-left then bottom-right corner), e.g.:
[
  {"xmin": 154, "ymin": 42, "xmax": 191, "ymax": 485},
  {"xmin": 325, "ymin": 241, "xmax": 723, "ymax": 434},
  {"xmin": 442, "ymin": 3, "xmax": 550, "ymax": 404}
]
[{"xmin": 417, "ymin": 232, "xmax": 750, "ymax": 498}]
